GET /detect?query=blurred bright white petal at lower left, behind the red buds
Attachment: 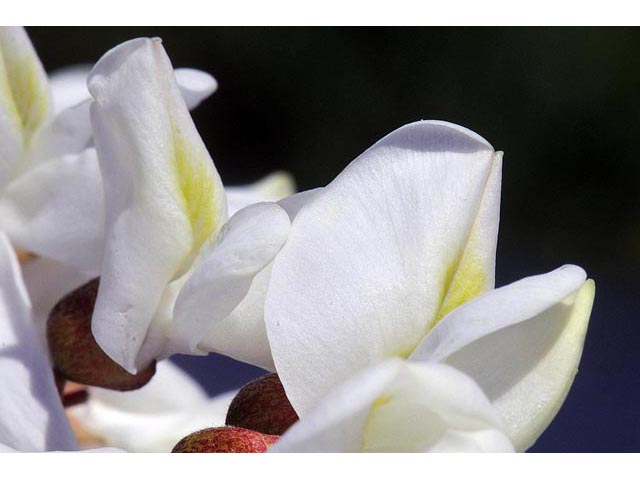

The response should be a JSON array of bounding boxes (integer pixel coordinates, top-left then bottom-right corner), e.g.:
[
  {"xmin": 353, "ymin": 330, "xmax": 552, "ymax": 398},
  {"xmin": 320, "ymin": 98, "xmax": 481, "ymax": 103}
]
[{"xmin": 69, "ymin": 361, "xmax": 237, "ymax": 452}]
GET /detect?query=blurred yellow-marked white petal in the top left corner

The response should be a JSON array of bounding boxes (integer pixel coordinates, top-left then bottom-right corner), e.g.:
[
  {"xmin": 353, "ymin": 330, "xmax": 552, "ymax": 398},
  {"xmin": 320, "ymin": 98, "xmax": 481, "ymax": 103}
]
[{"xmin": 0, "ymin": 27, "xmax": 51, "ymax": 185}]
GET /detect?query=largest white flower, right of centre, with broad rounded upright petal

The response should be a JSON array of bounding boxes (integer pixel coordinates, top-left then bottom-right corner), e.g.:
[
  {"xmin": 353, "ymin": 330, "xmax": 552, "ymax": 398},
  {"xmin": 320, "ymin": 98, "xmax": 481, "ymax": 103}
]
[{"xmin": 188, "ymin": 121, "xmax": 594, "ymax": 450}]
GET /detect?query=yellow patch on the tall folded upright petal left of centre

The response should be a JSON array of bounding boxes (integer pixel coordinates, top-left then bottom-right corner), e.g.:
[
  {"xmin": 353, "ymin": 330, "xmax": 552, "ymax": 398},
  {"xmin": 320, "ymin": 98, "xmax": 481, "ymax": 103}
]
[{"xmin": 174, "ymin": 130, "xmax": 220, "ymax": 258}]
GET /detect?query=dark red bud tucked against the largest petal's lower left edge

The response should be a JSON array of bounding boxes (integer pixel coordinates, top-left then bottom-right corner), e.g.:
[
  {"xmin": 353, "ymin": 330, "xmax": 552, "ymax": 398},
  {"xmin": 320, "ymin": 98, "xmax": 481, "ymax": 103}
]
[{"xmin": 226, "ymin": 373, "xmax": 298, "ymax": 435}]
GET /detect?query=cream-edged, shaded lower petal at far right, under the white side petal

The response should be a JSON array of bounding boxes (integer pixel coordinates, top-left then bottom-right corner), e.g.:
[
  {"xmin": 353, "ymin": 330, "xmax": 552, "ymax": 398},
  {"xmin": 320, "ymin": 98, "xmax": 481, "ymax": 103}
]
[{"xmin": 420, "ymin": 267, "xmax": 595, "ymax": 451}]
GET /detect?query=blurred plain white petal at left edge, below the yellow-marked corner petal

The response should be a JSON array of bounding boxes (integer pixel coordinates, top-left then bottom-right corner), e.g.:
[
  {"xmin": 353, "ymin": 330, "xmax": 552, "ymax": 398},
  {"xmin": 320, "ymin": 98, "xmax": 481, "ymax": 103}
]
[{"xmin": 0, "ymin": 149, "xmax": 104, "ymax": 276}]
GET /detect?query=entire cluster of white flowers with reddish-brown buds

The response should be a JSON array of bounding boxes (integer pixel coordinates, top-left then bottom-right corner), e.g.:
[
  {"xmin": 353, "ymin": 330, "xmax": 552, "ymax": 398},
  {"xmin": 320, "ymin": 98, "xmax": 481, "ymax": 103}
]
[{"xmin": 0, "ymin": 28, "xmax": 595, "ymax": 452}]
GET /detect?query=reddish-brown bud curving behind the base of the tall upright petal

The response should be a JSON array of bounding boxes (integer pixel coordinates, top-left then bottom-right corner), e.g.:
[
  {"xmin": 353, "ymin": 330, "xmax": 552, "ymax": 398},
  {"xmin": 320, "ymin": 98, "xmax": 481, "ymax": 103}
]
[{"xmin": 47, "ymin": 278, "xmax": 156, "ymax": 391}]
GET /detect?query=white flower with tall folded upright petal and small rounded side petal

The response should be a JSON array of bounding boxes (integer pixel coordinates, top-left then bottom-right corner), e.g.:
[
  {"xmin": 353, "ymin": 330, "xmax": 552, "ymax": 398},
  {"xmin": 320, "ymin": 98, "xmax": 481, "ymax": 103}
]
[{"xmin": 89, "ymin": 38, "xmax": 291, "ymax": 372}]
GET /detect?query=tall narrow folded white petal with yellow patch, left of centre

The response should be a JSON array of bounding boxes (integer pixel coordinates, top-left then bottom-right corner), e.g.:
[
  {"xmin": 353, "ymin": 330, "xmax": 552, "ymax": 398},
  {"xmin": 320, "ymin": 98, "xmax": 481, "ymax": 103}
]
[{"xmin": 89, "ymin": 38, "xmax": 226, "ymax": 372}]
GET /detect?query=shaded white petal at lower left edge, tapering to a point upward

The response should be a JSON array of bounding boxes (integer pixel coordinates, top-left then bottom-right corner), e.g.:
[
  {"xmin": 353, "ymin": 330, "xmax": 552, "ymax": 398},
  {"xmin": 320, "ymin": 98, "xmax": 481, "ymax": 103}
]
[{"xmin": 0, "ymin": 234, "xmax": 76, "ymax": 451}]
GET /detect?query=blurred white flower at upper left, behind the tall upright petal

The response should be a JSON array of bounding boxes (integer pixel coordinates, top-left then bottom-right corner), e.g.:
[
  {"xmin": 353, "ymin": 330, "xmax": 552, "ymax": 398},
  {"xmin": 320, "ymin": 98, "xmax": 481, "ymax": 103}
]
[{"xmin": 0, "ymin": 27, "xmax": 217, "ymax": 278}]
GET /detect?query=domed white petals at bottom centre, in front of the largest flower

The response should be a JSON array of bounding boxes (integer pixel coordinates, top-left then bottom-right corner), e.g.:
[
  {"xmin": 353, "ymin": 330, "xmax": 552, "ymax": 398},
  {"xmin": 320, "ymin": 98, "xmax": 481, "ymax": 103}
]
[{"xmin": 271, "ymin": 359, "xmax": 513, "ymax": 452}]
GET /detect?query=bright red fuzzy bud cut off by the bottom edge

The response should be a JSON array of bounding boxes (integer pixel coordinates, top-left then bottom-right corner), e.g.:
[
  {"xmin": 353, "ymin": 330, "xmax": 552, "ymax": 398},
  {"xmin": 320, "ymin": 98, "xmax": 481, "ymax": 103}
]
[{"xmin": 171, "ymin": 427, "xmax": 280, "ymax": 453}]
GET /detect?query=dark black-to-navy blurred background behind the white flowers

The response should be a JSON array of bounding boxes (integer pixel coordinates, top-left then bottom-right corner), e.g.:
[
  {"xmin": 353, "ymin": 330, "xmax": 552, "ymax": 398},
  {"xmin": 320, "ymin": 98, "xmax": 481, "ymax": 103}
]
[{"xmin": 28, "ymin": 27, "xmax": 640, "ymax": 452}]
